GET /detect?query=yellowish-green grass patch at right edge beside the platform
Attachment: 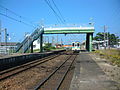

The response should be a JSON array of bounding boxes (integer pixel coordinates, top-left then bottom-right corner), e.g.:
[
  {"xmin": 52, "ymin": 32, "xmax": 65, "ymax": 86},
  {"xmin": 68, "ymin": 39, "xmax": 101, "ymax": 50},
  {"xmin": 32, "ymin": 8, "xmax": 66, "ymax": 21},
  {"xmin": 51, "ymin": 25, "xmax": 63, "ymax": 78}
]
[{"xmin": 93, "ymin": 49, "xmax": 120, "ymax": 67}]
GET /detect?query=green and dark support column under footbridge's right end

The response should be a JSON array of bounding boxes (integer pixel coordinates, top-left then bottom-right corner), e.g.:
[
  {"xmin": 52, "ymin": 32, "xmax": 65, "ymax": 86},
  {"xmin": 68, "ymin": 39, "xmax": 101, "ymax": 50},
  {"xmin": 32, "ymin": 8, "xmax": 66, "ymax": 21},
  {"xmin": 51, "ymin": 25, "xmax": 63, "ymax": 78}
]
[{"xmin": 86, "ymin": 33, "xmax": 93, "ymax": 52}]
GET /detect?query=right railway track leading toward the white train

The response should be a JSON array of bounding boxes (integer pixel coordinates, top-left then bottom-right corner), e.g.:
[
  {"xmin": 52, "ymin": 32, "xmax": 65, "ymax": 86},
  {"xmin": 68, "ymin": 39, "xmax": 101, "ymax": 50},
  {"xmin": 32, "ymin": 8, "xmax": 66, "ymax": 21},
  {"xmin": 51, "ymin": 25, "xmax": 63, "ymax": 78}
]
[{"xmin": 33, "ymin": 51, "xmax": 77, "ymax": 90}]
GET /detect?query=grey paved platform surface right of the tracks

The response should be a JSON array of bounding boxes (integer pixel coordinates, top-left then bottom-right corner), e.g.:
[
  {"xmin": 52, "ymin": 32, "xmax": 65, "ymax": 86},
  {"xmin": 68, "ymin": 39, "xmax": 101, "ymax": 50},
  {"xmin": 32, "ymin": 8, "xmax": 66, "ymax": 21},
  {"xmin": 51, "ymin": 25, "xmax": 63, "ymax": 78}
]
[{"xmin": 69, "ymin": 53, "xmax": 120, "ymax": 90}]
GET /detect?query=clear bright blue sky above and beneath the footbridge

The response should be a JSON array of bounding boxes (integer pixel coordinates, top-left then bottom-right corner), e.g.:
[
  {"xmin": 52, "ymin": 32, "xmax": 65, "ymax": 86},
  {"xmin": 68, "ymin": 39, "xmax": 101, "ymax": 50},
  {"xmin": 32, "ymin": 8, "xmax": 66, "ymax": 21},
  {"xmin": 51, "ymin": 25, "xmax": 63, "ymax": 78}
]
[{"xmin": 0, "ymin": 0, "xmax": 120, "ymax": 43}]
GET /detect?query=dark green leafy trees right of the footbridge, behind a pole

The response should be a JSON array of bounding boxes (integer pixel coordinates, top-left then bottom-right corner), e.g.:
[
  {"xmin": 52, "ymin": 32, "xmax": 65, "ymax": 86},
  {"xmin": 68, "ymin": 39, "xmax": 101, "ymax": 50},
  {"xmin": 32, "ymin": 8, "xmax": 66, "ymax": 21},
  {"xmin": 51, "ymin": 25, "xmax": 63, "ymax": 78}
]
[{"xmin": 93, "ymin": 32, "xmax": 119, "ymax": 46}]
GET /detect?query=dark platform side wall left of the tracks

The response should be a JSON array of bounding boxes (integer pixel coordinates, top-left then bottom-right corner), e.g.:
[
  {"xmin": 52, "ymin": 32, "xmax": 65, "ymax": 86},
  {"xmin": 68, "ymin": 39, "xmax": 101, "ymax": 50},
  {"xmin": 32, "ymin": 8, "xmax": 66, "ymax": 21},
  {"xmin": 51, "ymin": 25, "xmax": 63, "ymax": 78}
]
[{"xmin": 0, "ymin": 50, "xmax": 64, "ymax": 71}]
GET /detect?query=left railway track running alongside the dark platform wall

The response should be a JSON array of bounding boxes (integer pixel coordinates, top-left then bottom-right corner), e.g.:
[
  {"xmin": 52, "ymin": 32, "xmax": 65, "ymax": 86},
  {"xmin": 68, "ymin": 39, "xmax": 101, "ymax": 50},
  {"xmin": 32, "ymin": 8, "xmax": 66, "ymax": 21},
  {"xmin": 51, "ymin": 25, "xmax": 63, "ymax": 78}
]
[{"xmin": 0, "ymin": 54, "xmax": 60, "ymax": 81}]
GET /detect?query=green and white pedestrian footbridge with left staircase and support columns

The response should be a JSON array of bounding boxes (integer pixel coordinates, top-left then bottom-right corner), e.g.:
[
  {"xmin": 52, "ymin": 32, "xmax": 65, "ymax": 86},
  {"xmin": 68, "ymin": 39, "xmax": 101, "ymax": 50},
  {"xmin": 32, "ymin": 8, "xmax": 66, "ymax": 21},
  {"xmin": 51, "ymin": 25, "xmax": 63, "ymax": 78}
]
[{"xmin": 16, "ymin": 27, "xmax": 95, "ymax": 53}]
